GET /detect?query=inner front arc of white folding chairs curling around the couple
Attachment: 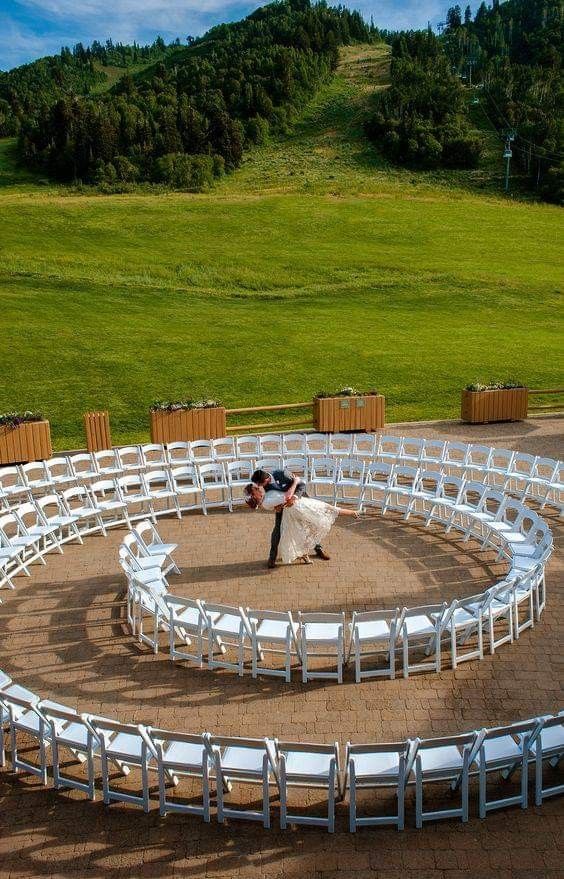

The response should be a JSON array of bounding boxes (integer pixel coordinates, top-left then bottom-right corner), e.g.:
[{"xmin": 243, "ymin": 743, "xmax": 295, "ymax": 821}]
[{"xmin": 119, "ymin": 520, "xmax": 545, "ymax": 683}]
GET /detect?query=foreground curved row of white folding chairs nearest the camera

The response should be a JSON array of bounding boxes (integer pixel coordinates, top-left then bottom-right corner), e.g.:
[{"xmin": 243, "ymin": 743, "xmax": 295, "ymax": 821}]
[{"xmin": 0, "ymin": 671, "xmax": 564, "ymax": 832}]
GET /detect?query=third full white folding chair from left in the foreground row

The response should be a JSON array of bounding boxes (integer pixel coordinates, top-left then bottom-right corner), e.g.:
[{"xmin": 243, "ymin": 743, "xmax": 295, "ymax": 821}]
[{"xmin": 88, "ymin": 715, "xmax": 157, "ymax": 812}]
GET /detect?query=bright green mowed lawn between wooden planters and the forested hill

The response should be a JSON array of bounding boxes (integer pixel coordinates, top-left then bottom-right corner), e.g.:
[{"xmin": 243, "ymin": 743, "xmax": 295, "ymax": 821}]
[{"xmin": 0, "ymin": 184, "xmax": 563, "ymax": 448}]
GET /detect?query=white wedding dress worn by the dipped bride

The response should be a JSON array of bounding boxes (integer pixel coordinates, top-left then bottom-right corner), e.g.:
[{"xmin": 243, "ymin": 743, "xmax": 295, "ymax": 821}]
[{"xmin": 262, "ymin": 490, "xmax": 339, "ymax": 565}]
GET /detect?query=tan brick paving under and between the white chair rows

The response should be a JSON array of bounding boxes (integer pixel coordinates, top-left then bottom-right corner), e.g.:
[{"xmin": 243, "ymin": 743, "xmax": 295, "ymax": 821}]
[{"xmin": 0, "ymin": 419, "xmax": 564, "ymax": 879}]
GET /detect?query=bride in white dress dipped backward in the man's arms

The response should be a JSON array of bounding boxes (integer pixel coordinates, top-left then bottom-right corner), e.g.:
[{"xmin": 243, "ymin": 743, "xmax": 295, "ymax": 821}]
[{"xmin": 245, "ymin": 482, "xmax": 360, "ymax": 565}]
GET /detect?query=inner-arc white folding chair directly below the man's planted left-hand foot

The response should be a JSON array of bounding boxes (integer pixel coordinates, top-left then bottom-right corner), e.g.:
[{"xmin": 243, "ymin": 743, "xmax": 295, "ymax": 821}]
[{"xmin": 246, "ymin": 608, "xmax": 301, "ymax": 683}]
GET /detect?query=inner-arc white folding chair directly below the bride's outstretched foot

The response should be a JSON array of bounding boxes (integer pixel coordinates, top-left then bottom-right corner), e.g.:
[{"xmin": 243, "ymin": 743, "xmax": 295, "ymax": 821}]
[{"xmin": 347, "ymin": 607, "xmax": 404, "ymax": 684}]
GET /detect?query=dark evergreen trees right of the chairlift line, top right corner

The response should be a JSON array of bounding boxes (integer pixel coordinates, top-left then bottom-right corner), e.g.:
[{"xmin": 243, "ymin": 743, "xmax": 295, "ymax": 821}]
[{"xmin": 443, "ymin": 0, "xmax": 564, "ymax": 203}]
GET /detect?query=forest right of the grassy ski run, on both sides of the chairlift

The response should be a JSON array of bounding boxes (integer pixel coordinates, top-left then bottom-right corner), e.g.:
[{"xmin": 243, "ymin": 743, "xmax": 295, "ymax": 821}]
[{"xmin": 366, "ymin": 0, "xmax": 564, "ymax": 202}]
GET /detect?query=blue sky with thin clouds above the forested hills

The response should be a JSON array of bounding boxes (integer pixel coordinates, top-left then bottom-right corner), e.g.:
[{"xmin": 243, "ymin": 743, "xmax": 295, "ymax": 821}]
[{"xmin": 0, "ymin": 0, "xmax": 476, "ymax": 70}]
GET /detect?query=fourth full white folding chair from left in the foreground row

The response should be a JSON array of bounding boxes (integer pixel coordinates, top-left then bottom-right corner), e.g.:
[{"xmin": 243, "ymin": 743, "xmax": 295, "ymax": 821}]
[{"xmin": 148, "ymin": 727, "xmax": 212, "ymax": 823}]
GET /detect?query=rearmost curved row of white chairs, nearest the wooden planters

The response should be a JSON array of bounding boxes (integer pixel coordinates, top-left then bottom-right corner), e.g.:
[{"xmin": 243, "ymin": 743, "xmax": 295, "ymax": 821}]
[{"xmin": 0, "ymin": 433, "xmax": 564, "ymax": 513}]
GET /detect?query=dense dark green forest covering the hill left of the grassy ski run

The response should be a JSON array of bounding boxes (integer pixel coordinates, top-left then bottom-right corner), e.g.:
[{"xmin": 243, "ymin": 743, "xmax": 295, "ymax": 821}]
[{"xmin": 9, "ymin": 0, "xmax": 375, "ymax": 189}]
